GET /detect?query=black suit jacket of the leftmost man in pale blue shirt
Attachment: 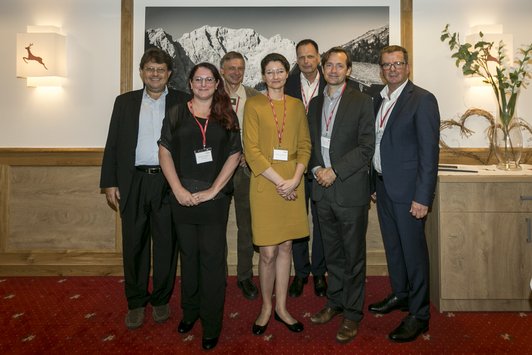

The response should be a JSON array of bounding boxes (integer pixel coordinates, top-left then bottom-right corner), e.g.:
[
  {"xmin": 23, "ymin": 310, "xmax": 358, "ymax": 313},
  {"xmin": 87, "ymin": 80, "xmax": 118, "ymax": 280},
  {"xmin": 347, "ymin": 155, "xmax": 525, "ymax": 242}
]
[{"xmin": 100, "ymin": 88, "xmax": 190, "ymax": 211}]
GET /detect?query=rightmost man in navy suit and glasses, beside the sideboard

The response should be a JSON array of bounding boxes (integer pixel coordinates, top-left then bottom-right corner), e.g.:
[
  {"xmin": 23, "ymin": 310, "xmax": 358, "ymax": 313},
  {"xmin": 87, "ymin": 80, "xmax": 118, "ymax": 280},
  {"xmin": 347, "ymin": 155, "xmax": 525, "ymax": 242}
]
[{"xmin": 368, "ymin": 46, "xmax": 440, "ymax": 342}]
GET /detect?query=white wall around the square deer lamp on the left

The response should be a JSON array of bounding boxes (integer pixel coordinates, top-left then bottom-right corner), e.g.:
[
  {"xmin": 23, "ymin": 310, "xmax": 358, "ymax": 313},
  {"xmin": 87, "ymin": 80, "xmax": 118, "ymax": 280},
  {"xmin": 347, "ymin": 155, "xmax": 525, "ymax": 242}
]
[{"xmin": 0, "ymin": 0, "xmax": 120, "ymax": 147}]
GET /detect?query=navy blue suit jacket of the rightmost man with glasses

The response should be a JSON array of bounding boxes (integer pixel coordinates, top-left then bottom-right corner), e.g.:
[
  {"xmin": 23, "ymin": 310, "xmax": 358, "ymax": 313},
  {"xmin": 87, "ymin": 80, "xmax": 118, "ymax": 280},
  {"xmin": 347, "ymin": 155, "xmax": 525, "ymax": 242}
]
[{"xmin": 374, "ymin": 81, "xmax": 440, "ymax": 206}]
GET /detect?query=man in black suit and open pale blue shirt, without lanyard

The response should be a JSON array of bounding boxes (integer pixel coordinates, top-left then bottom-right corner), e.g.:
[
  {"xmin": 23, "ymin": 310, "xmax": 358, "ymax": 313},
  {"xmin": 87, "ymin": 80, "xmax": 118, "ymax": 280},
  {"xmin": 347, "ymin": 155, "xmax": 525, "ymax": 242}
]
[{"xmin": 100, "ymin": 48, "xmax": 188, "ymax": 329}]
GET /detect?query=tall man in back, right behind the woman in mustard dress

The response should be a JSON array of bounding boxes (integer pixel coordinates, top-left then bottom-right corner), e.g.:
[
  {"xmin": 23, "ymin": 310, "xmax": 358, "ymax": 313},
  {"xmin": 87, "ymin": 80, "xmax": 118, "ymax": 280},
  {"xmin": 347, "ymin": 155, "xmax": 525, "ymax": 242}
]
[{"xmin": 285, "ymin": 39, "xmax": 327, "ymax": 297}]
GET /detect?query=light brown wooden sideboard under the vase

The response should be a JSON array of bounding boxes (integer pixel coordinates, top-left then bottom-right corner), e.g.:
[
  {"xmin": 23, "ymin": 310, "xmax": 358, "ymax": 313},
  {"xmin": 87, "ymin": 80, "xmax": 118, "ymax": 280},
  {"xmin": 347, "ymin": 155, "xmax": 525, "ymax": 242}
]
[{"xmin": 427, "ymin": 165, "xmax": 532, "ymax": 311}]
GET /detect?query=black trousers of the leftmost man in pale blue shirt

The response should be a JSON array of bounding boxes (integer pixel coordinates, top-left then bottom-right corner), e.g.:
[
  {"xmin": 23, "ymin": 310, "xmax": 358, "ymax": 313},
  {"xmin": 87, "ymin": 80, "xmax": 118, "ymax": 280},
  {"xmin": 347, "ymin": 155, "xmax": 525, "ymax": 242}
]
[{"xmin": 121, "ymin": 171, "xmax": 178, "ymax": 309}]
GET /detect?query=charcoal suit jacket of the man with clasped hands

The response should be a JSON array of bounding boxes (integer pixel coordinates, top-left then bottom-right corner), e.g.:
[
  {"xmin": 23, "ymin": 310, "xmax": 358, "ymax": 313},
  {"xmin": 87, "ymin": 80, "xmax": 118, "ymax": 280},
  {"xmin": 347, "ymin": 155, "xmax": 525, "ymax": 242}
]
[{"xmin": 308, "ymin": 86, "xmax": 375, "ymax": 207}]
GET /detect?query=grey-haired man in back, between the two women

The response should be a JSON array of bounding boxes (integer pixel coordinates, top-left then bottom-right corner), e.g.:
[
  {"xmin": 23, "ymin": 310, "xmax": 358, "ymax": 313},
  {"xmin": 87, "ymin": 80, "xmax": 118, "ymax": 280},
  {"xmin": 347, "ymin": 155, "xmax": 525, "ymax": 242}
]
[{"xmin": 220, "ymin": 52, "xmax": 260, "ymax": 300}]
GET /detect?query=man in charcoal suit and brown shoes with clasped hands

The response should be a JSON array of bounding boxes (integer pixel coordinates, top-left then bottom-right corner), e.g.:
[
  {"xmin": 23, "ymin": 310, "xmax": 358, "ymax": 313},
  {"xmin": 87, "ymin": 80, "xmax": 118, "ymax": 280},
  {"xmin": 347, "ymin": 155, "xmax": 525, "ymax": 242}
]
[{"xmin": 308, "ymin": 47, "xmax": 375, "ymax": 343}]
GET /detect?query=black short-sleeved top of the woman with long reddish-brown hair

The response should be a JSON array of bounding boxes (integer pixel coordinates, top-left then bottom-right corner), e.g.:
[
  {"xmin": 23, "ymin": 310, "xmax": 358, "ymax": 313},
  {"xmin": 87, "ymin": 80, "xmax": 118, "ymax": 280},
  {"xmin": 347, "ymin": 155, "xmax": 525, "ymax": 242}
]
[{"xmin": 159, "ymin": 103, "xmax": 242, "ymax": 224}]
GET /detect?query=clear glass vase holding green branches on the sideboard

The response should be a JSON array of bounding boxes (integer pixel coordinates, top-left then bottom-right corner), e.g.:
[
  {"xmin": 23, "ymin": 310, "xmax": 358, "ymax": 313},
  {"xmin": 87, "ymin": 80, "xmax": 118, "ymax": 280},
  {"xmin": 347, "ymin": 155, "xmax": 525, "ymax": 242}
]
[{"xmin": 492, "ymin": 116, "xmax": 523, "ymax": 170}]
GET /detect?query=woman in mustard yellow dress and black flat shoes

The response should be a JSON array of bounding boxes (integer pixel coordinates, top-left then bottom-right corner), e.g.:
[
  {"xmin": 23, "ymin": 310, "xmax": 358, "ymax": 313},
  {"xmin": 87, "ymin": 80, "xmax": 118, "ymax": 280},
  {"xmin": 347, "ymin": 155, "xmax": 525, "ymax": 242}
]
[{"xmin": 243, "ymin": 53, "xmax": 310, "ymax": 335}]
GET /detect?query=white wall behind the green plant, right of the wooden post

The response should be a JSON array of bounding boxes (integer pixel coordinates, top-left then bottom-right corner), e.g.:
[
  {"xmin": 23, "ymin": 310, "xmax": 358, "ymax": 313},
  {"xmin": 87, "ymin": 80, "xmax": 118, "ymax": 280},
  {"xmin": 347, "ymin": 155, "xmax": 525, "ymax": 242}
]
[{"xmin": 413, "ymin": 0, "xmax": 532, "ymax": 147}]
